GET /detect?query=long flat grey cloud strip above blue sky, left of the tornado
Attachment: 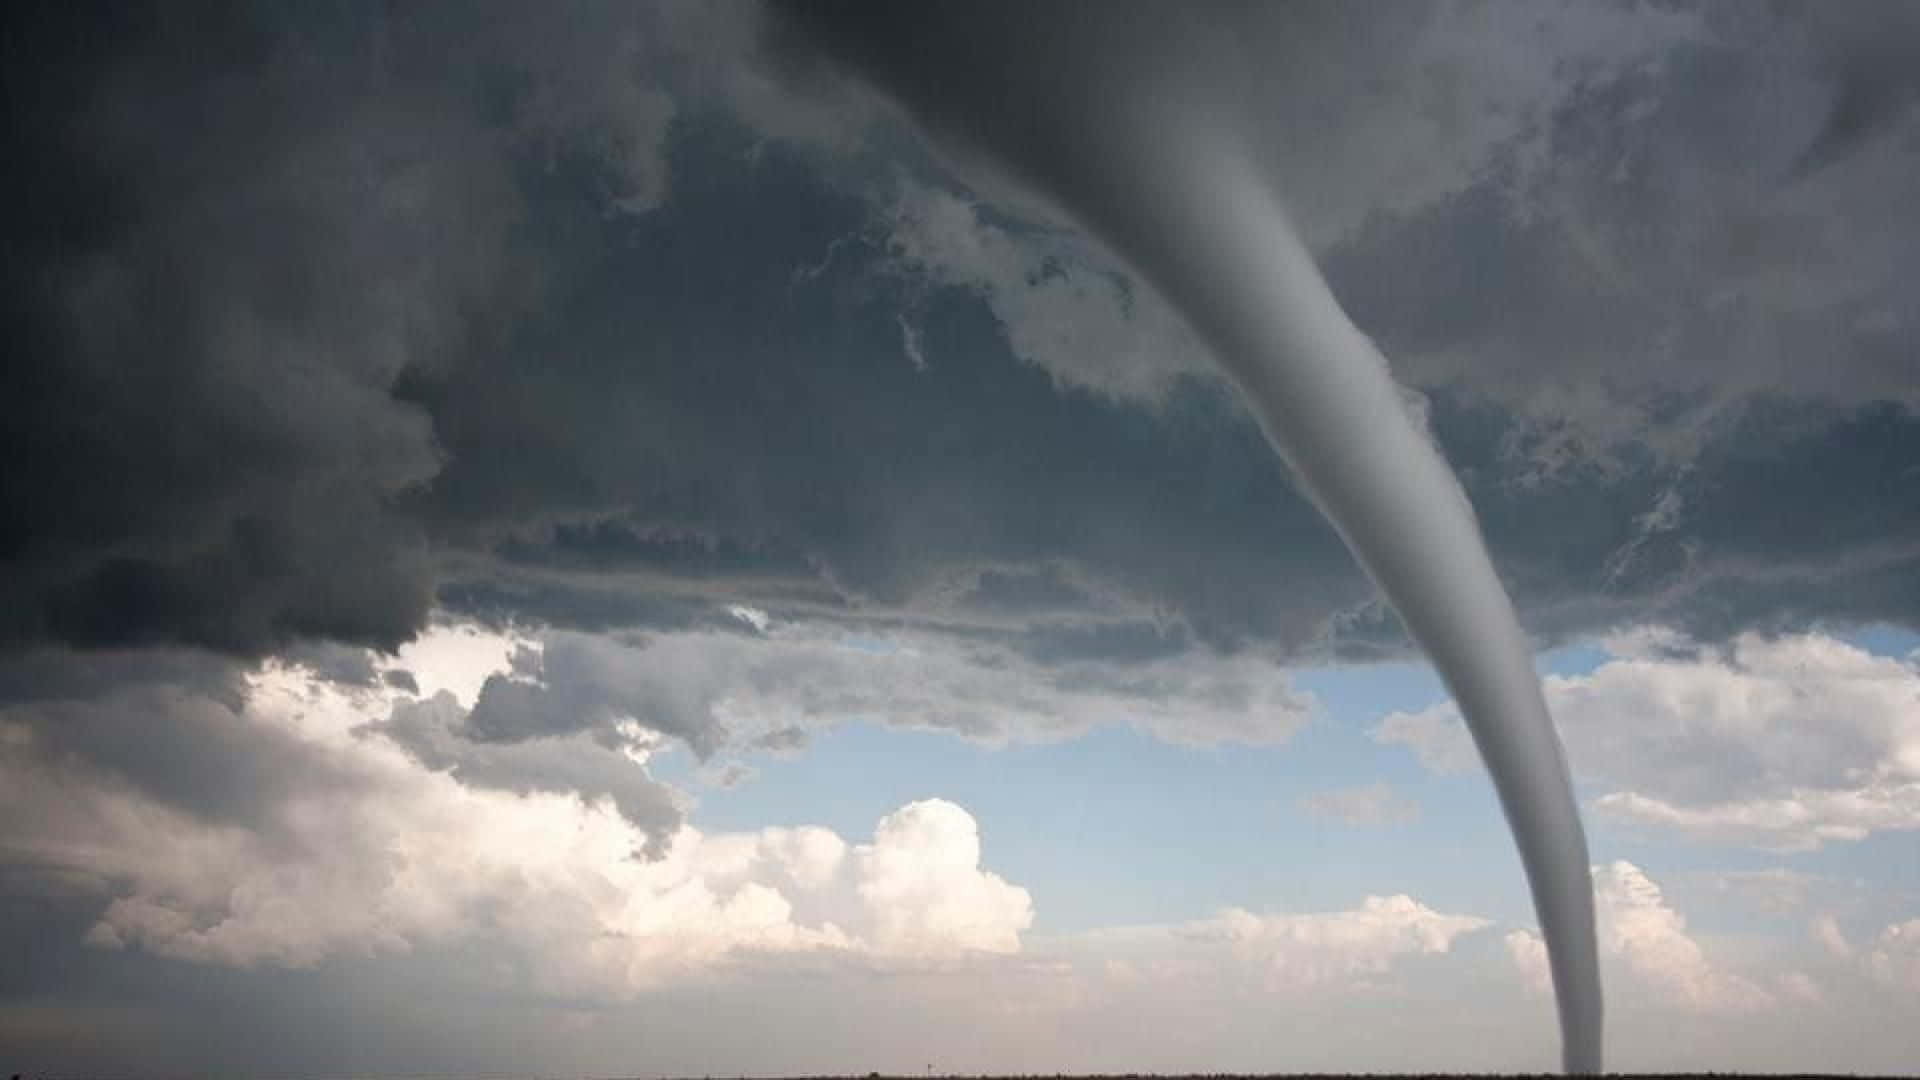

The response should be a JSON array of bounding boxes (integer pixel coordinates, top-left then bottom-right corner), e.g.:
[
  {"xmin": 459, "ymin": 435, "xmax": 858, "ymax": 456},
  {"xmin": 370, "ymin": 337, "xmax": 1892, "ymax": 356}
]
[{"xmin": 461, "ymin": 625, "xmax": 1317, "ymax": 759}]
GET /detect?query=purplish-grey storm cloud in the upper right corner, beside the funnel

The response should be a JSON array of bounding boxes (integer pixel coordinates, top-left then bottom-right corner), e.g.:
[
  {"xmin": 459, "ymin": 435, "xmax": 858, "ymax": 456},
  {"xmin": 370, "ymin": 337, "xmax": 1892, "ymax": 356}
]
[{"xmin": 1329, "ymin": 4, "xmax": 1920, "ymax": 420}]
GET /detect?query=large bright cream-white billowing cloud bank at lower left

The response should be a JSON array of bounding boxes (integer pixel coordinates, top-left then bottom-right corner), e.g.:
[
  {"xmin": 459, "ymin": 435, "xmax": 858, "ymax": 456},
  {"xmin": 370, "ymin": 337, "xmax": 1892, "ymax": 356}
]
[{"xmin": 0, "ymin": 645, "xmax": 1033, "ymax": 997}]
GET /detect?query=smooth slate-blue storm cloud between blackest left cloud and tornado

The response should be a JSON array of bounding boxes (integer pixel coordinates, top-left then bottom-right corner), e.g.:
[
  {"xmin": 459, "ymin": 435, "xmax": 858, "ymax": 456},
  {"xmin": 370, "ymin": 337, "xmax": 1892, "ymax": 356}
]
[{"xmin": 409, "ymin": 111, "xmax": 1363, "ymax": 644}]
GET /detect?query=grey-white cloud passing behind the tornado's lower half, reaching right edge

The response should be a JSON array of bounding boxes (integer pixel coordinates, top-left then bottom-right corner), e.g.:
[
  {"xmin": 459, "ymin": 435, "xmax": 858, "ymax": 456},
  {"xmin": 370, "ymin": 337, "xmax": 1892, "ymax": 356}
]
[{"xmin": 1373, "ymin": 632, "xmax": 1920, "ymax": 851}]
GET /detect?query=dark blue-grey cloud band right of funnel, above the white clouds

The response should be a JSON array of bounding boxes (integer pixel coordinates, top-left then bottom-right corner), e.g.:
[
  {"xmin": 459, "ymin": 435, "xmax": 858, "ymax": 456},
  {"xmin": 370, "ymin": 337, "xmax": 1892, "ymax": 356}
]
[{"xmin": 1413, "ymin": 394, "xmax": 1920, "ymax": 646}]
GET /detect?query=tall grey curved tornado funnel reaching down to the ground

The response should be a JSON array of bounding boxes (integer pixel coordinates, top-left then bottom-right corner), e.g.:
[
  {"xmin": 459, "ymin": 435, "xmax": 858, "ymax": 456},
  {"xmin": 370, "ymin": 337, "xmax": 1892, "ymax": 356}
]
[{"xmin": 772, "ymin": 0, "xmax": 1601, "ymax": 1074}]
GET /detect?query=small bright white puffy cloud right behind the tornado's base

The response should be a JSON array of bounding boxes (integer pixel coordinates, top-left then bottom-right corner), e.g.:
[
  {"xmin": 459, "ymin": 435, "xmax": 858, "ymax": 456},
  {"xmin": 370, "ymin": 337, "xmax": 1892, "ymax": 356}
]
[{"xmin": 1503, "ymin": 861, "xmax": 1766, "ymax": 1015}]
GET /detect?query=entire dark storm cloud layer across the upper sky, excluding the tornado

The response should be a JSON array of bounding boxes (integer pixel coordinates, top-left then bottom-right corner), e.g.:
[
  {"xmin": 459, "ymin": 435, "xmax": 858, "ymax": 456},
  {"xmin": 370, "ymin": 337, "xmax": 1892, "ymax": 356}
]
[{"xmin": 0, "ymin": 6, "xmax": 1920, "ymax": 653}]
